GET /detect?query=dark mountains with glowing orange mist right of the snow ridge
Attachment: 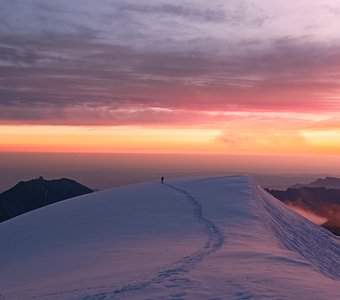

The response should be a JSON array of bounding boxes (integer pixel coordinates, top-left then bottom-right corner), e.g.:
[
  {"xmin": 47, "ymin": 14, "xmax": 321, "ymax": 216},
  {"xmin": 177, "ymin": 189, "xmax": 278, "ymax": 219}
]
[{"xmin": 267, "ymin": 177, "xmax": 340, "ymax": 235}]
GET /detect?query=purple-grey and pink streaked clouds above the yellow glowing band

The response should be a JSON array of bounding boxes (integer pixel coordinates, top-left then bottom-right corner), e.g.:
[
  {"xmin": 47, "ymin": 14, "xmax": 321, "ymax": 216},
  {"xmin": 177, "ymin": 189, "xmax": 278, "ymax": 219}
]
[{"xmin": 0, "ymin": 0, "xmax": 340, "ymax": 127}]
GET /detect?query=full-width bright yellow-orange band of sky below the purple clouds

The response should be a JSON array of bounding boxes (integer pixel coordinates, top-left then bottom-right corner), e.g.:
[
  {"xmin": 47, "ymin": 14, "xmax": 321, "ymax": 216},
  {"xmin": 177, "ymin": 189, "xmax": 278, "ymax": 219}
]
[{"xmin": 0, "ymin": 122, "xmax": 340, "ymax": 156}]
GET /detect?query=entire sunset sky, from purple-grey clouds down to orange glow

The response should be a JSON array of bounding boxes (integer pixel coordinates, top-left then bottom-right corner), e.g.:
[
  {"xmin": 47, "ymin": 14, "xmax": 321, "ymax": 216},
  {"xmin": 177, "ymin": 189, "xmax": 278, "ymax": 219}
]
[{"xmin": 0, "ymin": 0, "xmax": 340, "ymax": 169}]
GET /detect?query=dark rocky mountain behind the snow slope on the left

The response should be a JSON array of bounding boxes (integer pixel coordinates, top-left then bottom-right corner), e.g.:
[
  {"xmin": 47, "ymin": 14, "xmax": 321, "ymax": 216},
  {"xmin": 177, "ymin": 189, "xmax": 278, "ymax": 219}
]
[{"xmin": 0, "ymin": 177, "xmax": 93, "ymax": 222}]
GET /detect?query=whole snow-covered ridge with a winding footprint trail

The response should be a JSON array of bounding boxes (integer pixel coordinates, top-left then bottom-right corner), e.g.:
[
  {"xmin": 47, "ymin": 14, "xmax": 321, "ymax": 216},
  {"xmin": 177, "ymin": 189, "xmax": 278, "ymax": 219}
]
[{"xmin": 0, "ymin": 176, "xmax": 340, "ymax": 300}]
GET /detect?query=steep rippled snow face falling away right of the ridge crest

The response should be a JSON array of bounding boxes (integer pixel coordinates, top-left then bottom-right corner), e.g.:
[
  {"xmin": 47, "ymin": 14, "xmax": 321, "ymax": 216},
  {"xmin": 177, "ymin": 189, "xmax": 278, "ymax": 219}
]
[{"xmin": 253, "ymin": 185, "xmax": 340, "ymax": 280}]
